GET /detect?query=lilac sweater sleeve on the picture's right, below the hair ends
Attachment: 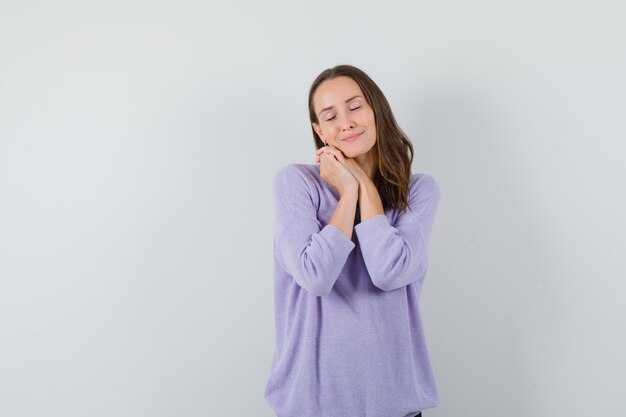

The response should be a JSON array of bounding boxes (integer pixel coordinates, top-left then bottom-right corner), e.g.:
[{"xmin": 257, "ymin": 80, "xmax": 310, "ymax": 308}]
[{"xmin": 354, "ymin": 174, "xmax": 440, "ymax": 291}]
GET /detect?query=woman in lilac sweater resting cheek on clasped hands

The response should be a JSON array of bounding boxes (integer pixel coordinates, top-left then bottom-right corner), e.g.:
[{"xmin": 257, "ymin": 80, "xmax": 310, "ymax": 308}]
[{"xmin": 265, "ymin": 65, "xmax": 439, "ymax": 417}]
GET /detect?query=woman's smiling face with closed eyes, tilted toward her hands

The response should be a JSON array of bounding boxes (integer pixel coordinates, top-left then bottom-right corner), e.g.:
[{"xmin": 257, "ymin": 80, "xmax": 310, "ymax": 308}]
[{"xmin": 313, "ymin": 76, "xmax": 376, "ymax": 158}]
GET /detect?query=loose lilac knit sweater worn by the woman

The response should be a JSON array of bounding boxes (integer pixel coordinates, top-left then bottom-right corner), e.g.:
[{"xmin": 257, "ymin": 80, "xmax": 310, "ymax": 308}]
[{"xmin": 265, "ymin": 164, "xmax": 439, "ymax": 417}]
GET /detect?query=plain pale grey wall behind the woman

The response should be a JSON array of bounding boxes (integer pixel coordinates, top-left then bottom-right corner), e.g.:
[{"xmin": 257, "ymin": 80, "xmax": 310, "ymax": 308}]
[{"xmin": 0, "ymin": 0, "xmax": 626, "ymax": 417}]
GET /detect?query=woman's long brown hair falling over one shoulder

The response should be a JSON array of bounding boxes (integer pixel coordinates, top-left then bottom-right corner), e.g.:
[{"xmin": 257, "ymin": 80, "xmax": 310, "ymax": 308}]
[{"xmin": 309, "ymin": 65, "xmax": 413, "ymax": 211}]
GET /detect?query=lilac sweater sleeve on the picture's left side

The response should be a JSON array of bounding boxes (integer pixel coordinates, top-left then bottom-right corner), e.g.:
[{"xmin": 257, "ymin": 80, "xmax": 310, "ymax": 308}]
[{"xmin": 274, "ymin": 164, "xmax": 356, "ymax": 296}]
